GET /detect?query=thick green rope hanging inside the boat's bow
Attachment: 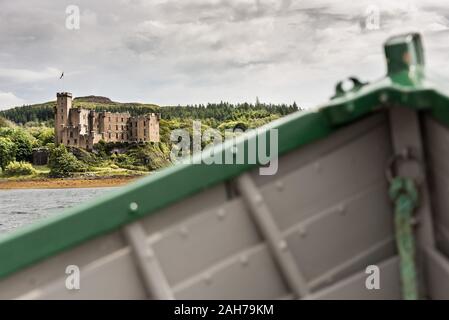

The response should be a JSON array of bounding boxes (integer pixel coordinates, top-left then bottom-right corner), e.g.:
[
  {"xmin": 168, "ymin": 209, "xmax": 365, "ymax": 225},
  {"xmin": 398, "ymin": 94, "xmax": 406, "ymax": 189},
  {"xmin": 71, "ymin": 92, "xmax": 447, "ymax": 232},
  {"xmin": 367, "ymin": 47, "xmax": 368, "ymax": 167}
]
[{"xmin": 389, "ymin": 177, "xmax": 419, "ymax": 300}]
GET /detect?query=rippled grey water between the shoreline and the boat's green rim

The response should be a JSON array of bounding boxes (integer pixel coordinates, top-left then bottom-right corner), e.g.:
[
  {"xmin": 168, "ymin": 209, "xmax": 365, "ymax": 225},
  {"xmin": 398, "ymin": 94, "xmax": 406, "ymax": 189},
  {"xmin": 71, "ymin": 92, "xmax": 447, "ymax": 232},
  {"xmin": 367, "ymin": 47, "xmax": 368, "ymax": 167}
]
[{"xmin": 0, "ymin": 188, "xmax": 115, "ymax": 234}]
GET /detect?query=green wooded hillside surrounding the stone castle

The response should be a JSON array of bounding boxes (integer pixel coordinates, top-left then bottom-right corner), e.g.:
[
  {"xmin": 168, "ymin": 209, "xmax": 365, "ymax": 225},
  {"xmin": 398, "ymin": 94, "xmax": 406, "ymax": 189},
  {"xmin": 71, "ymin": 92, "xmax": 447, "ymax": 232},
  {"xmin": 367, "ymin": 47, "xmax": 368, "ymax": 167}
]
[{"xmin": 0, "ymin": 96, "xmax": 298, "ymax": 180}]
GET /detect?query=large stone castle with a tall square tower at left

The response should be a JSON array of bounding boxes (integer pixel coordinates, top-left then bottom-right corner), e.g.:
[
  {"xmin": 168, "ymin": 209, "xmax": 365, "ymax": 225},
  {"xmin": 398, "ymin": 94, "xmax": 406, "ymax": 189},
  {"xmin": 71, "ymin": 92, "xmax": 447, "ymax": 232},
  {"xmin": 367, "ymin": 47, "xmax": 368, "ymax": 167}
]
[{"xmin": 55, "ymin": 92, "xmax": 160, "ymax": 150}]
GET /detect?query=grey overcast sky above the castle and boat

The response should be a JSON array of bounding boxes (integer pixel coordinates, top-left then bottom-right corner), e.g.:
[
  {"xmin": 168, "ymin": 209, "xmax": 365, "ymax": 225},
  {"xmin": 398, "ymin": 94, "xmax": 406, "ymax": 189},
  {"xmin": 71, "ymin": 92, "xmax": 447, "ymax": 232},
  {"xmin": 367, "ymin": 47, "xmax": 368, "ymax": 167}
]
[{"xmin": 0, "ymin": 0, "xmax": 449, "ymax": 109}]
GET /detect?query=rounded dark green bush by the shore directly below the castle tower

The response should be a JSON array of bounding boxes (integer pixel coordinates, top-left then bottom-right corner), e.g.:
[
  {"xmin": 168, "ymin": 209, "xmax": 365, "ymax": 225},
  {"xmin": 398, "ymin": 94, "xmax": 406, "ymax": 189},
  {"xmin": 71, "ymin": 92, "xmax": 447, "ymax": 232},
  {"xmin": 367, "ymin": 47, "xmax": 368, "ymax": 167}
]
[{"xmin": 48, "ymin": 145, "xmax": 87, "ymax": 177}]
